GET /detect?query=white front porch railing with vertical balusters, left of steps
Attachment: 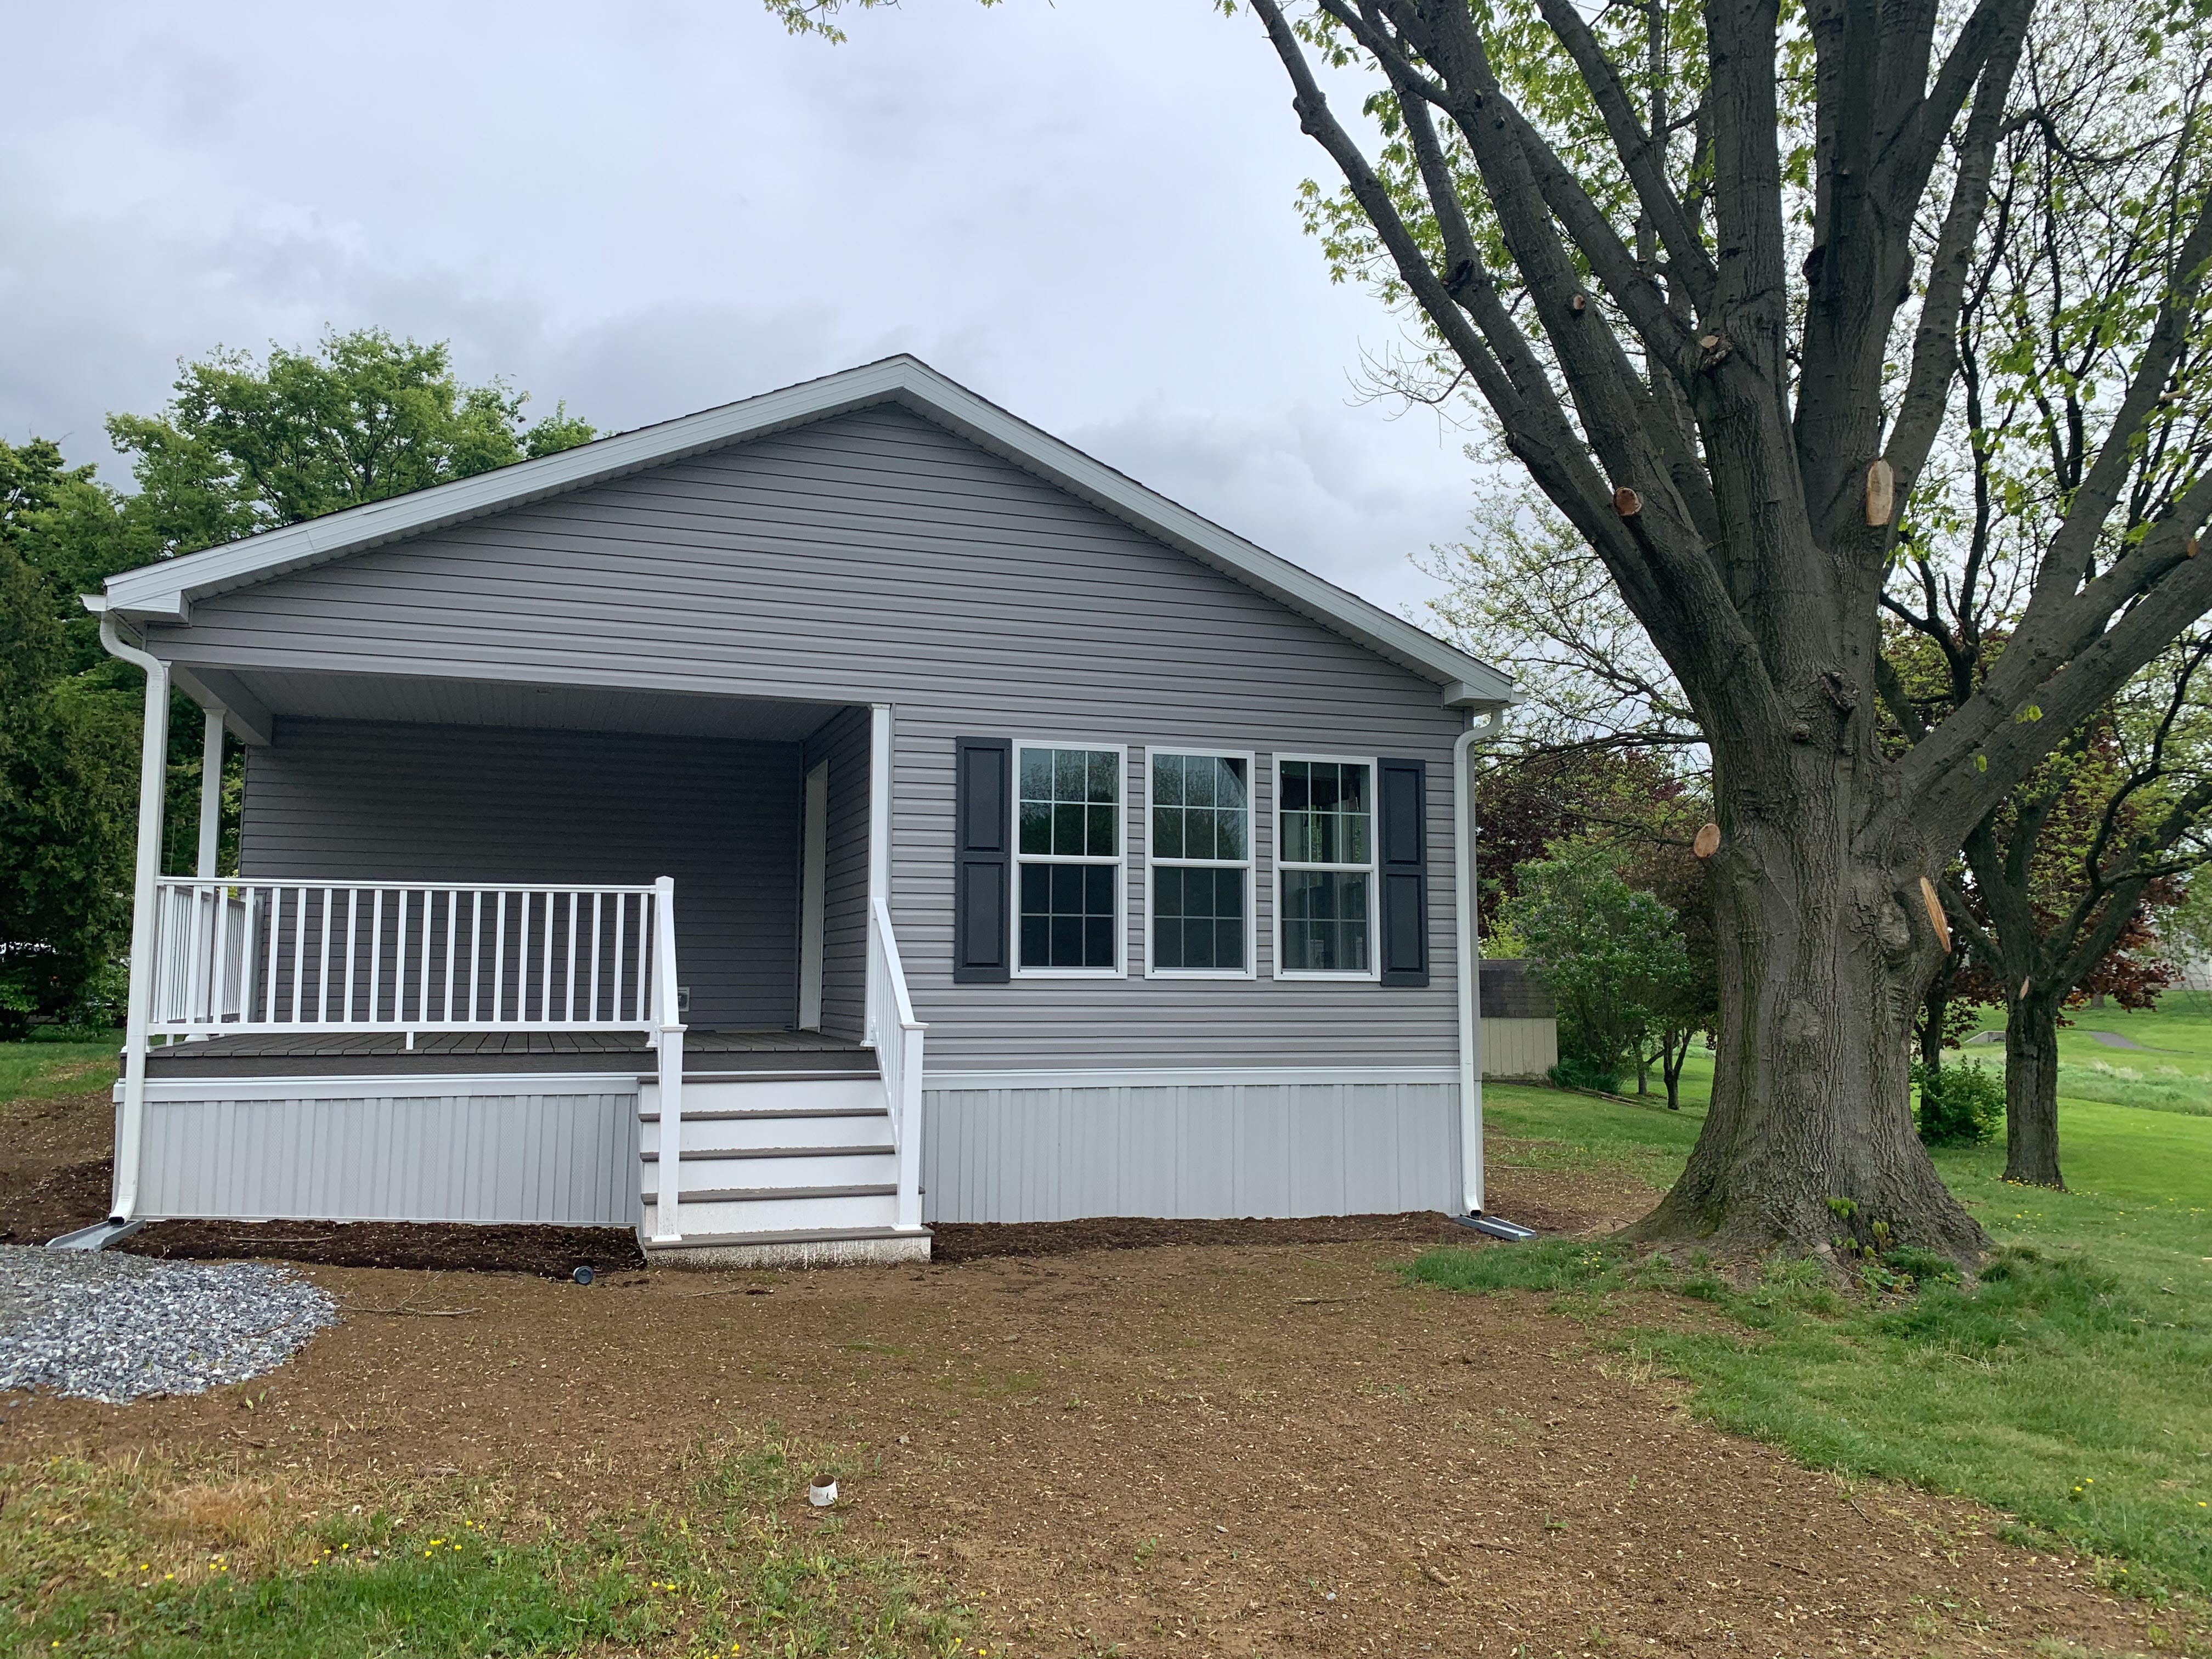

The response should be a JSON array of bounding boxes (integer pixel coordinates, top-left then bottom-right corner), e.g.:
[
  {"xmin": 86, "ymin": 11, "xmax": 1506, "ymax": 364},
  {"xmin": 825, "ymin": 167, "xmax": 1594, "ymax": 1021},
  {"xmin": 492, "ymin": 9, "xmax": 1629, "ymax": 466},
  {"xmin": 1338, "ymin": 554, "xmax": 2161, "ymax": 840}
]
[{"xmin": 148, "ymin": 876, "xmax": 677, "ymax": 1037}]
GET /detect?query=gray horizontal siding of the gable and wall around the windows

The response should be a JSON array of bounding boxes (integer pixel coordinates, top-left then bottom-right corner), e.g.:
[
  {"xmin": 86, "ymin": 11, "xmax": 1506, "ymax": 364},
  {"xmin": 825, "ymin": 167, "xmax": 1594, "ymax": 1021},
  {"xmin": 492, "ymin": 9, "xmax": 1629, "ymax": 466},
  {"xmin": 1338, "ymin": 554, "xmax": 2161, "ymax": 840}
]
[{"xmin": 157, "ymin": 407, "xmax": 1462, "ymax": 1070}]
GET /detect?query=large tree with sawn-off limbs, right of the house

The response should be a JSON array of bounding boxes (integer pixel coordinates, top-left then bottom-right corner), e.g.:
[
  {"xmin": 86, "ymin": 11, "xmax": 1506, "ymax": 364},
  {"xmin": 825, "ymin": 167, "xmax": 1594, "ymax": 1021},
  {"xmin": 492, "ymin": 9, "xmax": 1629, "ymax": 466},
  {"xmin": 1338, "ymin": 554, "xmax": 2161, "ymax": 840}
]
[{"xmin": 1250, "ymin": 0, "xmax": 2212, "ymax": 1259}]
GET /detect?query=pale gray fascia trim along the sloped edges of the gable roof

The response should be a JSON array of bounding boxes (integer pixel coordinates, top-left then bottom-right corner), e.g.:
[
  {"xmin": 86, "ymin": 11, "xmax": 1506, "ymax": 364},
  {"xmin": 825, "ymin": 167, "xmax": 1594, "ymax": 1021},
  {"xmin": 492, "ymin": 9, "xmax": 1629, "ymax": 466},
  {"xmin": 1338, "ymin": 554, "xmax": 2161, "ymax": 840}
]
[{"xmin": 104, "ymin": 356, "xmax": 1520, "ymax": 708}]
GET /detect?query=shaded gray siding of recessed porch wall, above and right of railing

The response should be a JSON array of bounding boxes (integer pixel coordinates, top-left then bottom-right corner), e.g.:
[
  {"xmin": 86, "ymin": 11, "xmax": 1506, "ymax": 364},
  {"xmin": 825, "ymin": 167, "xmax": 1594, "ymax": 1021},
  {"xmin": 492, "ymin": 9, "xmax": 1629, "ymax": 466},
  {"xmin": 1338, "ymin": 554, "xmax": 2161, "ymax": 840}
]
[{"xmin": 239, "ymin": 719, "xmax": 805, "ymax": 1029}]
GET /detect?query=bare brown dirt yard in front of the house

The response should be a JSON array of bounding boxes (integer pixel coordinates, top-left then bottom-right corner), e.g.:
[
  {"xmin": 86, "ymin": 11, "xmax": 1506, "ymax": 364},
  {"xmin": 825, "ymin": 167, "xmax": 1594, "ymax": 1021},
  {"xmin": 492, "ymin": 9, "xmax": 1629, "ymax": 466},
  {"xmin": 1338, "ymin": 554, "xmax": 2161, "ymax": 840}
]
[{"xmin": 0, "ymin": 1084, "xmax": 2154, "ymax": 1659}]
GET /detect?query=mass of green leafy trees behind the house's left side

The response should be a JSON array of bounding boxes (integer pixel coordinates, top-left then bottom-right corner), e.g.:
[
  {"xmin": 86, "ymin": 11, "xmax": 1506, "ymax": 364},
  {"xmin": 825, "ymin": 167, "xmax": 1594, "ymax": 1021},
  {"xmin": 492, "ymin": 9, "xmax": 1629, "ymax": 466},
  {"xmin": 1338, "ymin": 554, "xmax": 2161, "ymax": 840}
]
[{"xmin": 0, "ymin": 330, "xmax": 595, "ymax": 1035}]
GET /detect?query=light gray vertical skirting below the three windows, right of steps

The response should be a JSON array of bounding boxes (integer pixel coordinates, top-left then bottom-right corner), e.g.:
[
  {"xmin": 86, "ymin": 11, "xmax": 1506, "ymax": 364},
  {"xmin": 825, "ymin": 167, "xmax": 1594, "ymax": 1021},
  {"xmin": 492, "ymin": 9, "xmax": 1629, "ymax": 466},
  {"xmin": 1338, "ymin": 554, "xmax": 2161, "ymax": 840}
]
[{"xmin": 922, "ymin": 1080, "xmax": 1462, "ymax": 1221}]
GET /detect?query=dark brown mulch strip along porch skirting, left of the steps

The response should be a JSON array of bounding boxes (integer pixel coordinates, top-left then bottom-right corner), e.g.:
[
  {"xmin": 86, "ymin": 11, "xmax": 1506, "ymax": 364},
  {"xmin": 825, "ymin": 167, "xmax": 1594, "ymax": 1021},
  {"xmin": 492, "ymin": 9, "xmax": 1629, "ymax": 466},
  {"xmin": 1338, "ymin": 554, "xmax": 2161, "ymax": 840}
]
[{"xmin": 117, "ymin": 1221, "xmax": 646, "ymax": 1278}]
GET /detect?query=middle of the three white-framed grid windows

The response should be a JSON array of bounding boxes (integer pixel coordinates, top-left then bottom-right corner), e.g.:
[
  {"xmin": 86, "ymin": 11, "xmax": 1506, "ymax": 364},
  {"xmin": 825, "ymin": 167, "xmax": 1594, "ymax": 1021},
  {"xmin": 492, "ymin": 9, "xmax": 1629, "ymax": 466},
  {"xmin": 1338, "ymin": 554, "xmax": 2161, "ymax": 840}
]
[{"xmin": 1148, "ymin": 750, "xmax": 1252, "ymax": 975}]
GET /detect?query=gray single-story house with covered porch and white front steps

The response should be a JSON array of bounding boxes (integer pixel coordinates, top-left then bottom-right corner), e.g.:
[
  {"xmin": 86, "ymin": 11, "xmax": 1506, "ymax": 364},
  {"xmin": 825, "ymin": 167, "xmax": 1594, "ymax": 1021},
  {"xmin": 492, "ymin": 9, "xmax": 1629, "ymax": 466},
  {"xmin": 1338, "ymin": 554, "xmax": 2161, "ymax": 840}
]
[{"xmin": 86, "ymin": 356, "xmax": 1513, "ymax": 1261}]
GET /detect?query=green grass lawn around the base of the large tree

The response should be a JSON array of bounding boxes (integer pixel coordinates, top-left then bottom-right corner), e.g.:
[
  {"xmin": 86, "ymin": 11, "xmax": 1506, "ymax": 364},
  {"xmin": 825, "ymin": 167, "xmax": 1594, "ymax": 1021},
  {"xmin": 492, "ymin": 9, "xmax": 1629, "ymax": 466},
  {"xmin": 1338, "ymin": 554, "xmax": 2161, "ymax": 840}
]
[{"xmin": 1451, "ymin": 1084, "xmax": 2212, "ymax": 1593}]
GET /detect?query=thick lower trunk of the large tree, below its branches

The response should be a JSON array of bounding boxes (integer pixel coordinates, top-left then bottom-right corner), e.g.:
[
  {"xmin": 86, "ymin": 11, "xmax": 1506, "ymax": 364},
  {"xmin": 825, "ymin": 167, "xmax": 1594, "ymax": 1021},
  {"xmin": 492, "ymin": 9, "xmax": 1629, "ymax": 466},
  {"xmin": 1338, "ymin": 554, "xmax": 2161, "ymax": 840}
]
[{"xmin": 1630, "ymin": 805, "xmax": 1987, "ymax": 1263}]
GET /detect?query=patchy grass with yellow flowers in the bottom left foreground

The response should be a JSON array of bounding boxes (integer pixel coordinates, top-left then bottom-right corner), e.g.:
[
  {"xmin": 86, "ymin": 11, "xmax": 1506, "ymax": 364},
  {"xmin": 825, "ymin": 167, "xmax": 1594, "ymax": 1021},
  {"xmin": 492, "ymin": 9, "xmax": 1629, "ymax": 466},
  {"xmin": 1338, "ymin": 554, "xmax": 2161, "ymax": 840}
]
[{"xmin": 0, "ymin": 1436, "xmax": 967, "ymax": 1659}]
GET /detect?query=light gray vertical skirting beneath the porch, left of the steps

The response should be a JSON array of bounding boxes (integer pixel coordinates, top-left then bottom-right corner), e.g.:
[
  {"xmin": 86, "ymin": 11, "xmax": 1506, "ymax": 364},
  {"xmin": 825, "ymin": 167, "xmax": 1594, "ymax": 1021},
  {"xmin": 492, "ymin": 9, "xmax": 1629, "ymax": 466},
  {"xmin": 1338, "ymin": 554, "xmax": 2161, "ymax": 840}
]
[{"xmin": 137, "ymin": 1097, "xmax": 637, "ymax": 1228}]
